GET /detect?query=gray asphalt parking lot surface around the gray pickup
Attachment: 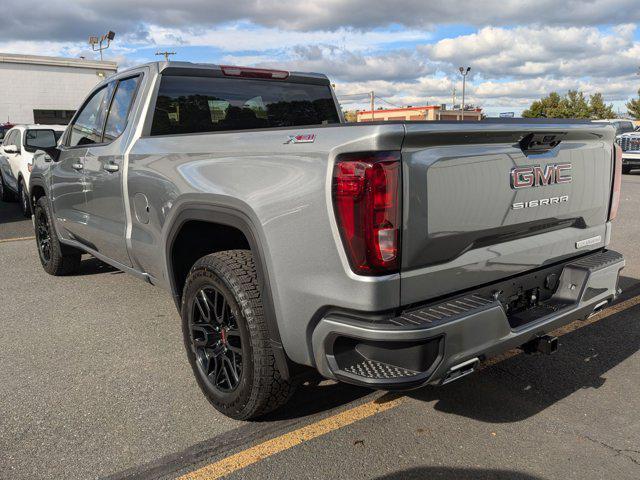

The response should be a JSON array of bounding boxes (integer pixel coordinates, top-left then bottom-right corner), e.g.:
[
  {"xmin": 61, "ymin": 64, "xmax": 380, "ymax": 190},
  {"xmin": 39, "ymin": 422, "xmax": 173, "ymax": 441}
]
[{"xmin": 0, "ymin": 172, "xmax": 640, "ymax": 480}]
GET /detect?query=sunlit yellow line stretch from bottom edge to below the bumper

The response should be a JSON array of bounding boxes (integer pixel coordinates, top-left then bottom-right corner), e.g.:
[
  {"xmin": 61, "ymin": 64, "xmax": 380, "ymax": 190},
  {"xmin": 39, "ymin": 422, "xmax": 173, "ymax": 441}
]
[{"xmin": 180, "ymin": 395, "xmax": 402, "ymax": 480}]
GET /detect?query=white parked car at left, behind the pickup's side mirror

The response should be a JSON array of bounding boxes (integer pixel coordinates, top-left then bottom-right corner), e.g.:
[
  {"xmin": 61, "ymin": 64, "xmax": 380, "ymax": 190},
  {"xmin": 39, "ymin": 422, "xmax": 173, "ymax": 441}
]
[{"xmin": 0, "ymin": 125, "xmax": 66, "ymax": 217}]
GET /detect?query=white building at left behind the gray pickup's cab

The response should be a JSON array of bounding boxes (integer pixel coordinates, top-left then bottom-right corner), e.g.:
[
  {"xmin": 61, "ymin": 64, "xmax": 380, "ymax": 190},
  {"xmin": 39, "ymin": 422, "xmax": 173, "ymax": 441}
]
[{"xmin": 0, "ymin": 53, "xmax": 118, "ymax": 125}]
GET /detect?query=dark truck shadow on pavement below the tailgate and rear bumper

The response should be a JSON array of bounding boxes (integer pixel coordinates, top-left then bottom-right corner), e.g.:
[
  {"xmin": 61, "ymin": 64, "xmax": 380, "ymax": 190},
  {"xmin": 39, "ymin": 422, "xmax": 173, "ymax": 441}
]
[{"xmin": 409, "ymin": 305, "xmax": 640, "ymax": 423}]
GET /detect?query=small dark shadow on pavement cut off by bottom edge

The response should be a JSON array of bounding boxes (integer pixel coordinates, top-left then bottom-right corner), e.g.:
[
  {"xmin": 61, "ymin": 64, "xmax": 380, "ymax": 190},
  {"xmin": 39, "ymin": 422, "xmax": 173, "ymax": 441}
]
[{"xmin": 376, "ymin": 467, "xmax": 542, "ymax": 480}]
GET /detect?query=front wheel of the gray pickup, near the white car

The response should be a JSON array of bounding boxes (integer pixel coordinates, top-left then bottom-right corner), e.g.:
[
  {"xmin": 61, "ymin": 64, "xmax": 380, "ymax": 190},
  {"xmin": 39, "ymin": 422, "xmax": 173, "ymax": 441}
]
[{"xmin": 33, "ymin": 196, "xmax": 82, "ymax": 276}]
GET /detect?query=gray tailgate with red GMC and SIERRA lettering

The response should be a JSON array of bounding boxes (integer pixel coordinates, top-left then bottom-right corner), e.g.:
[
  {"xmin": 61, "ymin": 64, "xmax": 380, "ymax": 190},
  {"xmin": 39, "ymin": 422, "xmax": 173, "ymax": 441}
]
[{"xmin": 401, "ymin": 122, "xmax": 614, "ymax": 305}]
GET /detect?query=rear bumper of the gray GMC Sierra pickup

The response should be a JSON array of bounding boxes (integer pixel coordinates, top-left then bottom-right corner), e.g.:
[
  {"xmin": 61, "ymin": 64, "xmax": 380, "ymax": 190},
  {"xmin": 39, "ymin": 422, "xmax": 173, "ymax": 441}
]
[{"xmin": 312, "ymin": 250, "xmax": 625, "ymax": 389}]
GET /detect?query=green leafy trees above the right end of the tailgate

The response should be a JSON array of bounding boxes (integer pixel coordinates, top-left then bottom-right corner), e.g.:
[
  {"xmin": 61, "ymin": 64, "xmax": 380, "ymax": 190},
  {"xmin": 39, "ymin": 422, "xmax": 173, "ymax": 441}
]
[{"xmin": 522, "ymin": 90, "xmax": 615, "ymax": 119}]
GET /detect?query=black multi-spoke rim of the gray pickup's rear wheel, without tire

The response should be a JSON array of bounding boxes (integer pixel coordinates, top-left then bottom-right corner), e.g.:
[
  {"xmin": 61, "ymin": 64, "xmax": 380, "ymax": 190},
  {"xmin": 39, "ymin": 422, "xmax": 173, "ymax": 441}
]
[{"xmin": 189, "ymin": 285, "xmax": 245, "ymax": 393}]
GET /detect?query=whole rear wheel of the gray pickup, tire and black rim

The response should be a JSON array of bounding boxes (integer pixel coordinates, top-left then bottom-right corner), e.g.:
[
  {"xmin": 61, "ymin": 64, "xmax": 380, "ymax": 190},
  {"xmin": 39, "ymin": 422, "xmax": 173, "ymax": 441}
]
[{"xmin": 181, "ymin": 250, "xmax": 293, "ymax": 420}]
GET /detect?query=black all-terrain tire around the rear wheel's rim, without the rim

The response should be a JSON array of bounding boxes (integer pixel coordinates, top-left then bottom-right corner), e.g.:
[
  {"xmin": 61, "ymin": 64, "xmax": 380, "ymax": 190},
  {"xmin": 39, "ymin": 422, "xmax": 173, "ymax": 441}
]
[{"xmin": 181, "ymin": 250, "xmax": 294, "ymax": 420}]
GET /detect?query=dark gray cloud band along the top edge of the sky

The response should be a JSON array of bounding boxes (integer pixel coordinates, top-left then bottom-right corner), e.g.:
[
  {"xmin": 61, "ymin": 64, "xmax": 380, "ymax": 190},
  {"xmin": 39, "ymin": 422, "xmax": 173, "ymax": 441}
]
[{"xmin": 2, "ymin": 0, "xmax": 640, "ymax": 41}]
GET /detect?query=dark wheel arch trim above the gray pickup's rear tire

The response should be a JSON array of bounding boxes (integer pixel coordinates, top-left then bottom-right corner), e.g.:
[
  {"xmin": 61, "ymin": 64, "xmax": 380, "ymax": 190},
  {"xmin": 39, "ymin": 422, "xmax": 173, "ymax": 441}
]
[{"xmin": 164, "ymin": 203, "xmax": 291, "ymax": 379}]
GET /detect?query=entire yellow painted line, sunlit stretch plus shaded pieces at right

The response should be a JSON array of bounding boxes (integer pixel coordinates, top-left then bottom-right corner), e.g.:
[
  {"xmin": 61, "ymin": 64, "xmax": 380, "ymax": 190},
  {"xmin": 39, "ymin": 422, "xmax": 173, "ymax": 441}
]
[{"xmin": 179, "ymin": 295, "xmax": 640, "ymax": 480}]
